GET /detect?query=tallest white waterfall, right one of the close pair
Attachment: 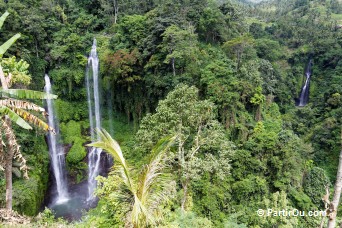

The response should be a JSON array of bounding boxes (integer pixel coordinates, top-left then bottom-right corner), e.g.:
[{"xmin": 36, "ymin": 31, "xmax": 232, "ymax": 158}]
[{"xmin": 86, "ymin": 39, "xmax": 102, "ymax": 201}]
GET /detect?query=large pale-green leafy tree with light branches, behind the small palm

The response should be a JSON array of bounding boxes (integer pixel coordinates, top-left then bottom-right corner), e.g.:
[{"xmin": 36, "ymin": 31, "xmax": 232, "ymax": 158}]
[{"xmin": 137, "ymin": 84, "xmax": 234, "ymax": 211}]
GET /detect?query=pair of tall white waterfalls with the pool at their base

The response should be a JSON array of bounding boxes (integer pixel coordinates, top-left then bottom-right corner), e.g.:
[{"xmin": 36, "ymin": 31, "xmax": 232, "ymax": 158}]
[{"xmin": 45, "ymin": 39, "xmax": 102, "ymax": 208}]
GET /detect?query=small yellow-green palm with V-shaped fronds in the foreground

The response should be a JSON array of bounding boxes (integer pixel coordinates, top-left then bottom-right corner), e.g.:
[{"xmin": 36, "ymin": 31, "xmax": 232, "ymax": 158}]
[{"xmin": 88, "ymin": 129, "xmax": 176, "ymax": 227}]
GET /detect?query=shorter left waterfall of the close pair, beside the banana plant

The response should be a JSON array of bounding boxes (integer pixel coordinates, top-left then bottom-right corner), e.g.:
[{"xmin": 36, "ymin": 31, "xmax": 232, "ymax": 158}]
[{"xmin": 45, "ymin": 75, "xmax": 68, "ymax": 204}]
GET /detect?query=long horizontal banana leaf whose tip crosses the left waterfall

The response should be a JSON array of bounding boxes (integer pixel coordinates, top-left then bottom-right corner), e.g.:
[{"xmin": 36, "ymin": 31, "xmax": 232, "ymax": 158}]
[{"xmin": 0, "ymin": 89, "xmax": 57, "ymax": 99}]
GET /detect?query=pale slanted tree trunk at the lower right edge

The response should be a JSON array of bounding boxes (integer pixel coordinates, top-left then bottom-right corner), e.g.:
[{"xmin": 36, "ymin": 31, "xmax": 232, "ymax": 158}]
[{"xmin": 328, "ymin": 149, "xmax": 342, "ymax": 228}]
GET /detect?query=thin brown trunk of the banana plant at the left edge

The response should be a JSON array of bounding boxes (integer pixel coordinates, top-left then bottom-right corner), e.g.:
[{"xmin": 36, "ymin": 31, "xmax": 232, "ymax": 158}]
[{"xmin": 3, "ymin": 116, "xmax": 14, "ymax": 211}]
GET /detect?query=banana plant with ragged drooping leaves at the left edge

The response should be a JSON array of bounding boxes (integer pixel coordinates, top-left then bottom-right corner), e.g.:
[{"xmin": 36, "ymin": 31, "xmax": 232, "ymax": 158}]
[{"xmin": 0, "ymin": 12, "xmax": 57, "ymax": 211}]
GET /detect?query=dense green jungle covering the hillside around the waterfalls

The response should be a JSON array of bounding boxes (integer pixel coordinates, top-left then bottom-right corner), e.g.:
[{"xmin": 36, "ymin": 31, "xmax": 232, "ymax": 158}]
[{"xmin": 0, "ymin": 0, "xmax": 342, "ymax": 227}]
